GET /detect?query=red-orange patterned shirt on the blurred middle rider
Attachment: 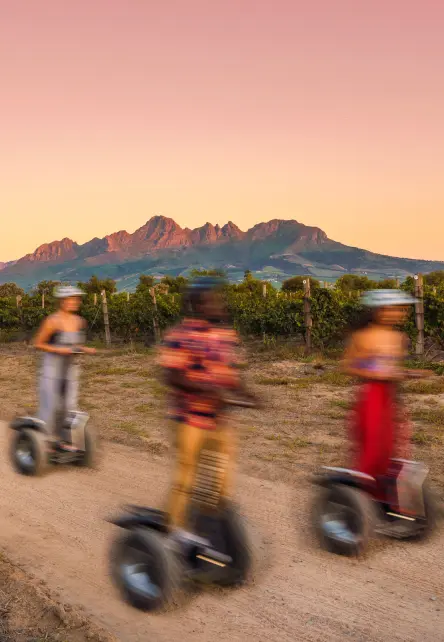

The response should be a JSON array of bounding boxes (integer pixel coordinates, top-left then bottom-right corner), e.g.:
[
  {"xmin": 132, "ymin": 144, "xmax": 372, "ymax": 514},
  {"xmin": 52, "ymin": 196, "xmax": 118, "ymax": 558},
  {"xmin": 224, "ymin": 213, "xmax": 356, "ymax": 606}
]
[{"xmin": 159, "ymin": 319, "xmax": 239, "ymax": 430}]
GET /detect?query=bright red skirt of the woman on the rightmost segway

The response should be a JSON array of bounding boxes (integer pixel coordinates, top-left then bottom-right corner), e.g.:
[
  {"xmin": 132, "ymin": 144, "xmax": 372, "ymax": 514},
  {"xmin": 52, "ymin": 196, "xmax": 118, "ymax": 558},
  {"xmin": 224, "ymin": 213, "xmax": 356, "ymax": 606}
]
[{"xmin": 351, "ymin": 381, "xmax": 410, "ymax": 478}]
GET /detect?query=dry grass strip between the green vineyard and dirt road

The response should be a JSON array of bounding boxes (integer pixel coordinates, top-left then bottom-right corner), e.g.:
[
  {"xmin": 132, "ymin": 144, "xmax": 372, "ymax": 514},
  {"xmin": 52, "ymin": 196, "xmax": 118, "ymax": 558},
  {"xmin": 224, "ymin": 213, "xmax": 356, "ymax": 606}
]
[{"xmin": 0, "ymin": 346, "xmax": 444, "ymax": 487}]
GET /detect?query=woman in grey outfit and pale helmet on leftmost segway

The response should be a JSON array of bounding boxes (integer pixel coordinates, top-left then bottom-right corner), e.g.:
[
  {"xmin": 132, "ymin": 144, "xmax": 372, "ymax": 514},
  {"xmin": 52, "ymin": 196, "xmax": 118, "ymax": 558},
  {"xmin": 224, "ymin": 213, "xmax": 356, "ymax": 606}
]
[{"xmin": 34, "ymin": 286, "xmax": 96, "ymax": 451}]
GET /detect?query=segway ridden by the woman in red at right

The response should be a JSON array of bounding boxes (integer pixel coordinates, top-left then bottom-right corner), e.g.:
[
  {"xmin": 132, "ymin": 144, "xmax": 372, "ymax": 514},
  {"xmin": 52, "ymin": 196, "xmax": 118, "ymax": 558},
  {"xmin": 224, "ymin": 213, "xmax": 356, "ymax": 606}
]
[{"xmin": 313, "ymin": 459, "xmax": 437, "ymax": 556}]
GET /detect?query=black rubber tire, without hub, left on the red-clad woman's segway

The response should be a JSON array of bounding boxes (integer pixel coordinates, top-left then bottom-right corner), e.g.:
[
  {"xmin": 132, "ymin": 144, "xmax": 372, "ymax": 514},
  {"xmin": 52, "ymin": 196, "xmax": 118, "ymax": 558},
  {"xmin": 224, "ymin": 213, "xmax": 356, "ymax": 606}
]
[{"xmin": 312, "ymin": 484, "xmax": 375, "ymax": 556}]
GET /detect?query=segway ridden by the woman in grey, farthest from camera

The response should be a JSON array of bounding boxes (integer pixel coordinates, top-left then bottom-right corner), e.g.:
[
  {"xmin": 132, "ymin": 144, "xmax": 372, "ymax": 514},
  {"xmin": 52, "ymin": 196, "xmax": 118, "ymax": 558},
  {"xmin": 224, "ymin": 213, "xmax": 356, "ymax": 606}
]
[{"xmin": 10, "ymin": 351, "xmax": 96, "ymax": 476}]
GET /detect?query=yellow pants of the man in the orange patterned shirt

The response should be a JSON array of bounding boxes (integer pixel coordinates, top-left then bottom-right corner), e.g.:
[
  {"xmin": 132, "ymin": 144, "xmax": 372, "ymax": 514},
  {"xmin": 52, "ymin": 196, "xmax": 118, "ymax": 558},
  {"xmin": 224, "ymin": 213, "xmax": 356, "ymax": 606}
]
[{"xmin": 167, "ymin": 424, "xmax": 236, "ymax": 528}]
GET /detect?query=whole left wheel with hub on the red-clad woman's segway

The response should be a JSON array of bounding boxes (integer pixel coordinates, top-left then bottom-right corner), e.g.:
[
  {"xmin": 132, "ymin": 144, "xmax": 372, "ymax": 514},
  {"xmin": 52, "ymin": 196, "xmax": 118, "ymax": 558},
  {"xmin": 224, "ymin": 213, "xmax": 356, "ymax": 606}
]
[{"xmin": 313, "ymin": 484, "xmax": 374, "ymax": 556}]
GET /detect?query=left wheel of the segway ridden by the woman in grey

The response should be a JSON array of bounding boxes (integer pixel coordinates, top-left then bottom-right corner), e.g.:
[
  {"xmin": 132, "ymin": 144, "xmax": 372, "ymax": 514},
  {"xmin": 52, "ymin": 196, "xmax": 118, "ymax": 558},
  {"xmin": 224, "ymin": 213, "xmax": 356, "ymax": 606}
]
[{"xmin": 11, "ymin": 428, "xmax": 49, "ymax": 476}]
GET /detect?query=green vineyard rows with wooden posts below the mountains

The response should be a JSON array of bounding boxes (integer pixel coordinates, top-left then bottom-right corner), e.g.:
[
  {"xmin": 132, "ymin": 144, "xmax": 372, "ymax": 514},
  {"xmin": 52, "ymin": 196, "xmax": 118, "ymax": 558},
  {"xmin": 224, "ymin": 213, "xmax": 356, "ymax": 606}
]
[{"xmin": 0, "ymin": 274, "xmax": 444, "ymax": 349}]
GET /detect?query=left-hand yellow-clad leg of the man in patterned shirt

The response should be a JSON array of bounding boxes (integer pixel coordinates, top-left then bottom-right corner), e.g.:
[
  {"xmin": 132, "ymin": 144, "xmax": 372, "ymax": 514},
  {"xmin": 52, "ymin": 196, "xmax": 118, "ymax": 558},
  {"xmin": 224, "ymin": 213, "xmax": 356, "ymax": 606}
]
[{"xmin": 167, "ymin": 424, "xmax": 206, "ymax": 529}]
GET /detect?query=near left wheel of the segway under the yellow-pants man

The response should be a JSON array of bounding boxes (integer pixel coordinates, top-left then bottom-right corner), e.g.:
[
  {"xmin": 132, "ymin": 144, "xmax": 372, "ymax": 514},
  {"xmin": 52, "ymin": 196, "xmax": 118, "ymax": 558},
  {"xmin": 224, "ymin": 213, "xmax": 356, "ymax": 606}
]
[{"xmin": 110, "ymin": 529, "xmax": 180, "ymax": 611}]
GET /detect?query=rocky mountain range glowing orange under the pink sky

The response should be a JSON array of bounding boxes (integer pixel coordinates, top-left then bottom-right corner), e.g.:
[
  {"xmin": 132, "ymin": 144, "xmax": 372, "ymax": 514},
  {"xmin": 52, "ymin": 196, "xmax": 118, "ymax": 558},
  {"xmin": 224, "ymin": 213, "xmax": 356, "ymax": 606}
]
[{"xmin": 0, "ymin": 216, "xmax": 444, "ymax": 290}]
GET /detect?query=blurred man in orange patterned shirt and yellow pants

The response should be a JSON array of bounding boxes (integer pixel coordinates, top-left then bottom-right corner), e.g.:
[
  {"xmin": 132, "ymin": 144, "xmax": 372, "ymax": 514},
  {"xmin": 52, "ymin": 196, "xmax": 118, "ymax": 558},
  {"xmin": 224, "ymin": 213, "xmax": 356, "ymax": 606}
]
[{"xmin": 160, "ymin": 277, "xmax": 248, "ymax": 540}]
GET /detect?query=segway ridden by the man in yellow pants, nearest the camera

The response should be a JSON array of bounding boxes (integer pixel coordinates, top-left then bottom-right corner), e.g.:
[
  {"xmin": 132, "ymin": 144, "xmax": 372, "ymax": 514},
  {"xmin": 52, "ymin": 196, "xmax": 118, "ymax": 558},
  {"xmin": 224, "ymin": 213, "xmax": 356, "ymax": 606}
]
[{"xmin": 108, "ymin": 392, "xmax": 255, "ymax": 611}]
